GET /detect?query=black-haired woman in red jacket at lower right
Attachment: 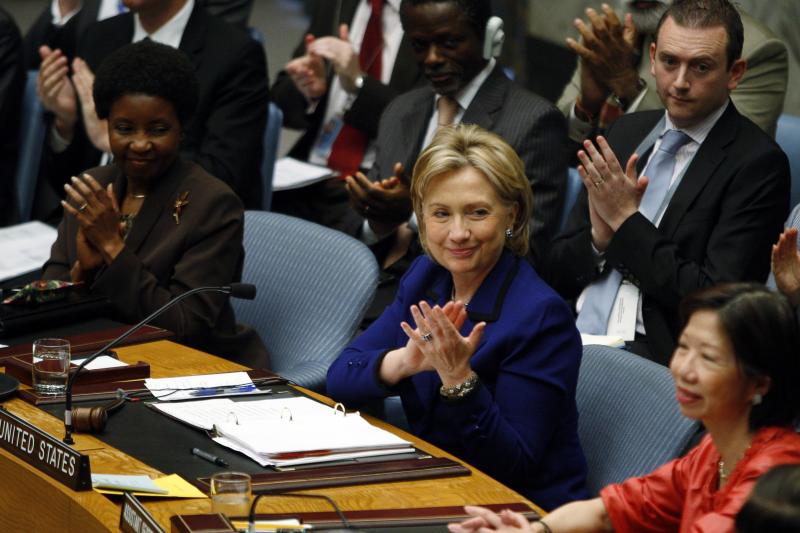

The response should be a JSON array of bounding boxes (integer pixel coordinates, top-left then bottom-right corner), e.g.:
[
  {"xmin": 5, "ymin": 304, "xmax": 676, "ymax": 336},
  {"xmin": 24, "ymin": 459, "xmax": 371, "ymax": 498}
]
[{"xmin": 450, "ymin": 283, "xmax": 800, "ymax": 533}]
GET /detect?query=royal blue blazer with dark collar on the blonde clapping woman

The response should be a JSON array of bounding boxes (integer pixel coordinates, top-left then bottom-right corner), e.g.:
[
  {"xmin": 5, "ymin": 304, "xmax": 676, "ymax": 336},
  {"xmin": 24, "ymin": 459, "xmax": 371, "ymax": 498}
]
[{"xmin": 327, "ymin": 250, "xmax": 587, "ymax": 509}]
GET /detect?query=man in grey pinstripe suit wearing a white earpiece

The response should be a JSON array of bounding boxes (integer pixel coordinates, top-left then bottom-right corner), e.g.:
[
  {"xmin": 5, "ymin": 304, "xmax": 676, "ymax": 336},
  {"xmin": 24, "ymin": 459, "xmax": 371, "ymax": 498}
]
[{"xmin": 347, "ymin": 0, "xmax": 566, "ymax": 266}]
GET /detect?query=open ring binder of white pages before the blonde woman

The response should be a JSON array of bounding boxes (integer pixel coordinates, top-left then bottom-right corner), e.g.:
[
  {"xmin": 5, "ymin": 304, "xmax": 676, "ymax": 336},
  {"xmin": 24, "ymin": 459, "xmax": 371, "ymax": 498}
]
[{"xmin": 151, "ymin": 397, "xmax": 413, "ymax": 466}]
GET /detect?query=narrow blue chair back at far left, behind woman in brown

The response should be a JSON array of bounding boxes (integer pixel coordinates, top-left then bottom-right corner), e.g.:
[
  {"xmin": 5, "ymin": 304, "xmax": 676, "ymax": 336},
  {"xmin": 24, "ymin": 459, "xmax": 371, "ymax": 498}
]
[{"xmin": 14, "ymin": 70, "xmax": 45, "ymax": 222}]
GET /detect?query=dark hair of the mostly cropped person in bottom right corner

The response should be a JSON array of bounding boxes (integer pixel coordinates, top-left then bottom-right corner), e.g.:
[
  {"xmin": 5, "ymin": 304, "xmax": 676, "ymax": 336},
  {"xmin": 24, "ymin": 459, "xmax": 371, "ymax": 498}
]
[{"xmin": 736, "ymin": 464, "xmax": 800, "ymax": 533}]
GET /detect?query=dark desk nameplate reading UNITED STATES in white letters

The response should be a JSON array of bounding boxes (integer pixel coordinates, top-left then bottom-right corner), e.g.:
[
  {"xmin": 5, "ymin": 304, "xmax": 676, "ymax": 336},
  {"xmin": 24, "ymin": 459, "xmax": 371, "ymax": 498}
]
[{"xmin": 0, "ymin": 407, "xmax": 92, "ymax": 490}]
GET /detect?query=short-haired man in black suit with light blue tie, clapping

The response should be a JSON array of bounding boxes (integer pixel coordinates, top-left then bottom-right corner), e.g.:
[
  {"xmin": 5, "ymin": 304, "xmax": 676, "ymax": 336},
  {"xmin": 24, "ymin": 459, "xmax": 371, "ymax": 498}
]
[{"xmin": 545, "ymin": 0, "xmax": 789, "ymax": 364}]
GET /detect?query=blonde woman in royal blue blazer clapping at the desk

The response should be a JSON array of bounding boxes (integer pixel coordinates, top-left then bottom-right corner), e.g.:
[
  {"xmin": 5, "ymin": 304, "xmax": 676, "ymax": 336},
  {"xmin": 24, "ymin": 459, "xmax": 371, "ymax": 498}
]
[{"xmin": 327, "ymin": 126, "xmax": 586, "ymax": 508}]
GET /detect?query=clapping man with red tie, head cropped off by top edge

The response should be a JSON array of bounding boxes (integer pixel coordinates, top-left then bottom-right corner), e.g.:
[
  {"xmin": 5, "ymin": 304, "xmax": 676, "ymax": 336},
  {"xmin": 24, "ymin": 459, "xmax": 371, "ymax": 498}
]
[{"xmin": 272, "ymin": 0, "xmax": 423, "ymax": 231}]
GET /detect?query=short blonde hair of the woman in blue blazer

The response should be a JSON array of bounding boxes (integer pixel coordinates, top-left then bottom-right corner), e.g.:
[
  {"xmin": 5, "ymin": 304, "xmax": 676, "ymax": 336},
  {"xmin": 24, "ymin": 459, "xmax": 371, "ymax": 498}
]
[{"xmin": 411, "ymin": 124, "xmax": 533, "ymax": 256}]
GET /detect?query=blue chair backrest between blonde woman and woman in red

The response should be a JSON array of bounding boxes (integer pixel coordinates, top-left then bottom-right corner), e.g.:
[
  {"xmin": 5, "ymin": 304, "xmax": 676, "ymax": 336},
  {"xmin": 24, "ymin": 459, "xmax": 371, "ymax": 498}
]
[{"xmin": 577, "ymin": 346, "xmax": 698, "ymax": 495}]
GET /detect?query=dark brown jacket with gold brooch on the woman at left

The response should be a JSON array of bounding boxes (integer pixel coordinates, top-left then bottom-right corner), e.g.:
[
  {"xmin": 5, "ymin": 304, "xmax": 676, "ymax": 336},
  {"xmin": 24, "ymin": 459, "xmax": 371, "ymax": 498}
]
[{"xmin": 43, "ymin": 158, "xmax": 269, "ymax": 367}]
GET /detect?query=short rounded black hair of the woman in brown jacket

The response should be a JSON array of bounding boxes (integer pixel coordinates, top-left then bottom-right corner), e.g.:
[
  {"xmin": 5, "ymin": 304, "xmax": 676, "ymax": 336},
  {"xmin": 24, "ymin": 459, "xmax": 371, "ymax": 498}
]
[{"xmin": 93, "ymin": 40, "xmax": 198, "ymax": 125}]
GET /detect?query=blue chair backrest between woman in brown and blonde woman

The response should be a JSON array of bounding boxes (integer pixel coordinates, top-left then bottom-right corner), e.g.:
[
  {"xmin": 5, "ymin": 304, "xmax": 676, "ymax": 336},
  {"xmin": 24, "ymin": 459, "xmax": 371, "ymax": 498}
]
[{"xmin": 231, "ymin": 211, "xmax": 378, "ymax": 391}]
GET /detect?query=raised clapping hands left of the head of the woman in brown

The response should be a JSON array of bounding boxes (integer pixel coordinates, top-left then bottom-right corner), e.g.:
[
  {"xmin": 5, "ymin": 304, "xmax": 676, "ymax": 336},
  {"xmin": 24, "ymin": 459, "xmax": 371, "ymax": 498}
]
[{"xmin": 36, "ymin": 46, "xmax": 110, "ymax": 152}]
